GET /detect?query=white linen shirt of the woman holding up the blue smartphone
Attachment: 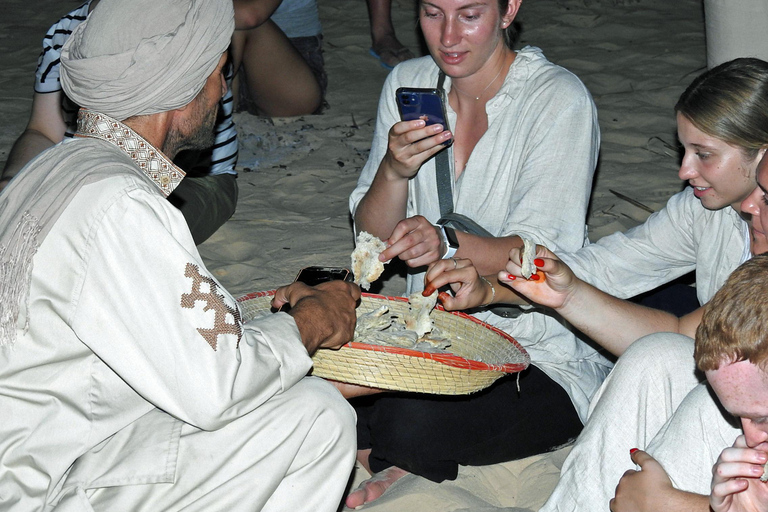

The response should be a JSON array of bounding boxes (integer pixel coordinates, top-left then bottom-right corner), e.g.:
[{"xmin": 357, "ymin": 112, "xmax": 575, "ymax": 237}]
[{"xmin": 350, "ymin": 47, "xmax": 611, "ymax": 421}]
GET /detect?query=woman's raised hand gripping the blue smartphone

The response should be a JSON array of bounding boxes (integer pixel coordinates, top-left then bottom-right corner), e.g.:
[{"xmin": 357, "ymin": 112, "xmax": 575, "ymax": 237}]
[{"xmin": 382, "ymin": 119, "xmax": 453, "ymax": 179}]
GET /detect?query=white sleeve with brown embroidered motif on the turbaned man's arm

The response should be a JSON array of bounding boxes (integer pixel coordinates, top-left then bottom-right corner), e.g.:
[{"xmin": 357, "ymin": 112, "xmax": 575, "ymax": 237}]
[{"xmin": 70, "ymin": 189, "xmax": 311, "ymax": 430}]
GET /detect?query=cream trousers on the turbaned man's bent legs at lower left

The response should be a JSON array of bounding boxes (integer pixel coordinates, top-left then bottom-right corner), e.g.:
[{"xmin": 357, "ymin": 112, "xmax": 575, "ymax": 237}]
[{"xmin": 55, "ymin": 378, "xmax": 357, "ymax": 512}]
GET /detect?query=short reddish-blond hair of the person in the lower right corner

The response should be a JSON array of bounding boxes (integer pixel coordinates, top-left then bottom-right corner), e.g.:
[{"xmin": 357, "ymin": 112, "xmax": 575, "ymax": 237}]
[{"xmin": 693, "ymin": 253, "xmax": 768, "ymax": 371}]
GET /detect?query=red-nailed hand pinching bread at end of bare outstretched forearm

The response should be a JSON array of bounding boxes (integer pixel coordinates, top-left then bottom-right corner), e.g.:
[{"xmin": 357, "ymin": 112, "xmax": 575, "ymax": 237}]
[{"xmin": 498, "ymin": 245, "xmax": 582, "ymax": 309}]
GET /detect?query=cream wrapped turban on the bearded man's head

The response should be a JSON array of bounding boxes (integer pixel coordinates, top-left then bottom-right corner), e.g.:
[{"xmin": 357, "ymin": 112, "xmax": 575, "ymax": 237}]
[{"xmin": 61, "ymin": 0, "xmax": 235, "ymax": 121}]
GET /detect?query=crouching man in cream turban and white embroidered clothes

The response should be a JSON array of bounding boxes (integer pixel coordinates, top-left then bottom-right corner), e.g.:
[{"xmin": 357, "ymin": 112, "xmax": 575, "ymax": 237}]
[{"xmin": 0, "ymin": 0, "xmax": 360, "ymax": 512}]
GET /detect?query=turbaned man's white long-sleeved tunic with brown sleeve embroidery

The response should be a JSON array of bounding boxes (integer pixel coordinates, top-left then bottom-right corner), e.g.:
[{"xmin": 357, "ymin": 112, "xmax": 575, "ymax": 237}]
[{"xmin": 0, "ymin": 119, "xmax": 311, "ymax": 510}]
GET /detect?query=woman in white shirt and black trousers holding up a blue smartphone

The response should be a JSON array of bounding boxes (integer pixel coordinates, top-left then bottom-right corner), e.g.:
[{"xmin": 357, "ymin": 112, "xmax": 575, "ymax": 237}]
[{"xmin": 347, "ymin": 0, "xmax": 611, "ymax": 507}]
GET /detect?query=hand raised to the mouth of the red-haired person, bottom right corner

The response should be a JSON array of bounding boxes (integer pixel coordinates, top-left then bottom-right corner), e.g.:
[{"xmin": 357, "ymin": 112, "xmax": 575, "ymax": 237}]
[{"xmin": 709, "ymin": 435, "xmax": 768, "ymax": 512}]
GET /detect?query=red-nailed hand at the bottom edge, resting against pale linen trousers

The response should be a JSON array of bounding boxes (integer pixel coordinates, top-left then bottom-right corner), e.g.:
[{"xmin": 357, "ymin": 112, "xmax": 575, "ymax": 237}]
[{"xmin": 610, "ymin": 450, "xmax": 709, "ymax": 512}]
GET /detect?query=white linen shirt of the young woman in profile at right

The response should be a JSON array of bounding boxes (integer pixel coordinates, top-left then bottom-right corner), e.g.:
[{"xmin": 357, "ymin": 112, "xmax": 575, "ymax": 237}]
[{"xmin": 558, "ymin": 187, "xmax": 750, "ymax": 305}]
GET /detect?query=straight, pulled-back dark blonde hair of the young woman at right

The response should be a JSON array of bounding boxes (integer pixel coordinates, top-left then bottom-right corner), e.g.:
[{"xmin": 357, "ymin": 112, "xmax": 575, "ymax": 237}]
[{"xmin": 675, "ymin": 58, "xmax": 768, "ymax": 159}]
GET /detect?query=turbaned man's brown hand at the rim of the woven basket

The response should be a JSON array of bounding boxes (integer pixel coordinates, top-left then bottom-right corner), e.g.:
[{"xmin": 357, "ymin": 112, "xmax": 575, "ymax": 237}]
[{"xmin": 272, "ymin": 281, "xmax": 360, "ymax": 355}]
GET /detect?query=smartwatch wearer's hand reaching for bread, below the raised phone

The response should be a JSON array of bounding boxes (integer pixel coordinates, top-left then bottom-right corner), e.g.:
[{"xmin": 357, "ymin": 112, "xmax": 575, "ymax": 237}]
[{"xmin": 379, "ymin": 215, "xmax": 444, "ymax": 268}]
